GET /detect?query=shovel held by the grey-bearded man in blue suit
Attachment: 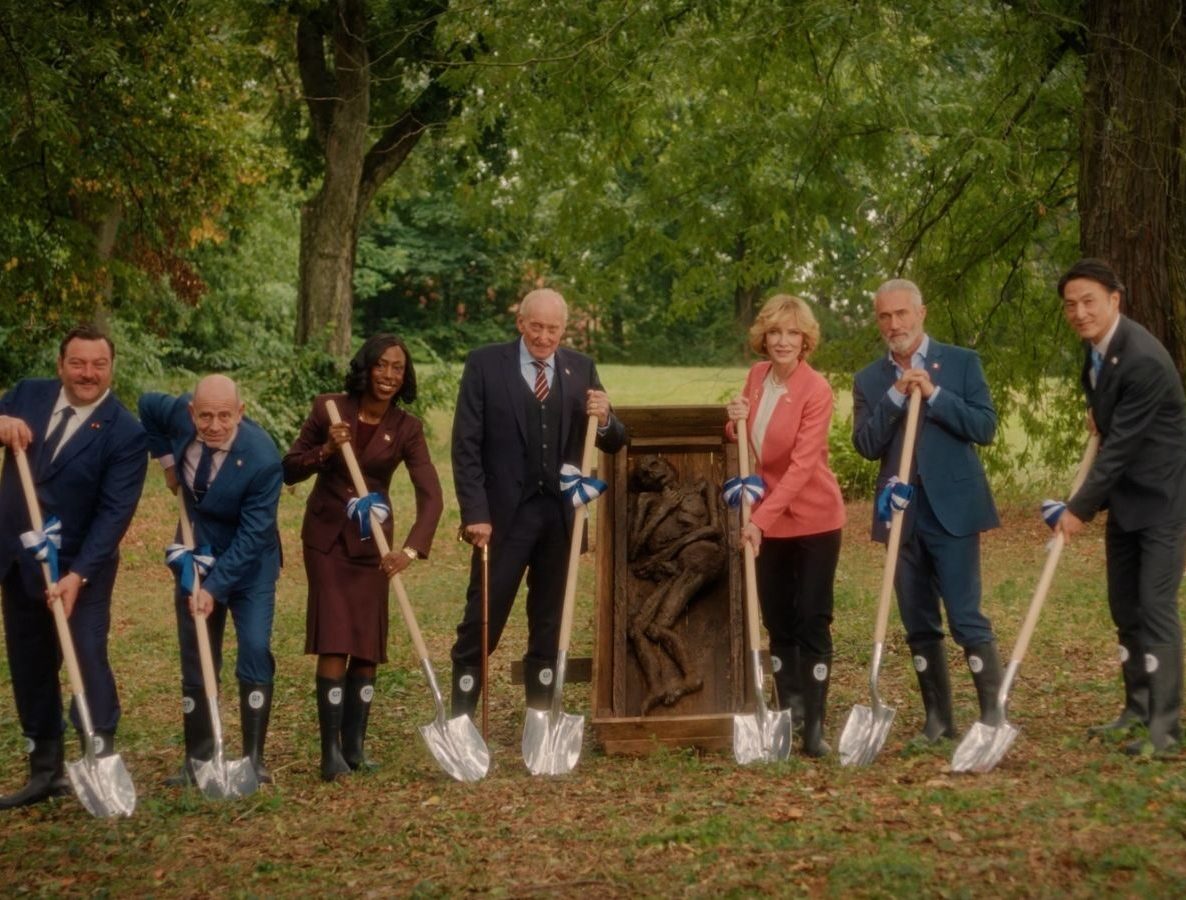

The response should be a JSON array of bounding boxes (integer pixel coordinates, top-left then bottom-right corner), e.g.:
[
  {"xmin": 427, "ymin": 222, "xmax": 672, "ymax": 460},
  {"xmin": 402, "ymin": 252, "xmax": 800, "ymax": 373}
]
[{"xmin": 840, "ymin": 389, "xmax": 923, "ymax": 766}]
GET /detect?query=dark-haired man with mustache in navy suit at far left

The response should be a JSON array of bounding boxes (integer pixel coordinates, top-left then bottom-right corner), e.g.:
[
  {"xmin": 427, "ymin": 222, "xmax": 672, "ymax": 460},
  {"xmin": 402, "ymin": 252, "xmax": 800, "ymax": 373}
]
[{"xmin": 0, "ymin": 326, "xmax": 147, "ymax": 809}]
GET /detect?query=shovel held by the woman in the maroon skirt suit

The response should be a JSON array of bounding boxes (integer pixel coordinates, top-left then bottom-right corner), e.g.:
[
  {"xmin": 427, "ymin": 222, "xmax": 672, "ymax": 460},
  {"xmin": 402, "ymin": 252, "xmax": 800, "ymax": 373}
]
[{"xmin": 325, "ymin": 400, "xmax": 490, "ymax": 781}]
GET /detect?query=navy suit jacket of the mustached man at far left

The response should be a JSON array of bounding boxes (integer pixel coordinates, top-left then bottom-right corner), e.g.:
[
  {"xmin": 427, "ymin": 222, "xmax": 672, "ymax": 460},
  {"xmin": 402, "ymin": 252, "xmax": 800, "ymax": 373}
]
[{"xmin": 0, "ymin": 378, "xmax": 148, "ymax": 594}]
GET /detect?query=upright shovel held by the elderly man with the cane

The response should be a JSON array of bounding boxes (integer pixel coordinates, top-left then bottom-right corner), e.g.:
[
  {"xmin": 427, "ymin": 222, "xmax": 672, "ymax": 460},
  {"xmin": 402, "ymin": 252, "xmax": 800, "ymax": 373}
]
[{"xmin": 523, "ymin": 416, "xmax": 597, "ymax": 775}]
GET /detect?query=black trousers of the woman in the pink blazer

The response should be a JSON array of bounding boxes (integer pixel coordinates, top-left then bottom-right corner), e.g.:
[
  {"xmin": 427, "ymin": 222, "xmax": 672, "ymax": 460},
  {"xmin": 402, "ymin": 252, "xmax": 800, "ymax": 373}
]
[{"xmin": 757, "ymin": 530, "xmax": 842, "ymax": 657}]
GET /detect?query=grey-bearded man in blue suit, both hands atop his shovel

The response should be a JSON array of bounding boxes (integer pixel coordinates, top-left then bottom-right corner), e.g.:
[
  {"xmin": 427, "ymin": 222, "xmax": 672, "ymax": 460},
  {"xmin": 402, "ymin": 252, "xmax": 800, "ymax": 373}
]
[{"xmin": 853, "ymin": 279, "xmax": 1001, "ymax": 741}]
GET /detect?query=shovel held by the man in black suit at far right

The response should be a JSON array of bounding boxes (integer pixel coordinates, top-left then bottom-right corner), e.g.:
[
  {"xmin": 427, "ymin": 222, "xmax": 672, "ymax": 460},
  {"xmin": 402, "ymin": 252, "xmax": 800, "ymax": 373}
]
[{"xmin": 951, "ymin": 434, "xmax": 1099, "ymax": 772}]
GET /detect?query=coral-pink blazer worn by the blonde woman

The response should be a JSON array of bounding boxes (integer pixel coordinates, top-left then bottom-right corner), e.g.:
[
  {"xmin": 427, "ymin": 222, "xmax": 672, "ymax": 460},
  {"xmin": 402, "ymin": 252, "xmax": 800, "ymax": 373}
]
[{"xmin": 727, "ymin": 362, "xmax": 846, "ymax": 537}]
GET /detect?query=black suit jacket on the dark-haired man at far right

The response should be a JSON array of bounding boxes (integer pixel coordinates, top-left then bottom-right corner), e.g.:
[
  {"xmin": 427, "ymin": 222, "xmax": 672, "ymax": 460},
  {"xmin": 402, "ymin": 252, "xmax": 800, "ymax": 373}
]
[{"xmin": 1066, "ymin": 315, "xmax": 1186, "ymax": 531}]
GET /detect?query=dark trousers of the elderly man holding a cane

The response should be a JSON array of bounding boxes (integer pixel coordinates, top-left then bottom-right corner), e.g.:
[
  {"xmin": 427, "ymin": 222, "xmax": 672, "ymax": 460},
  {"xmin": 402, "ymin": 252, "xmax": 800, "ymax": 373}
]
[{"xmin": 452, "ymin": 493, "xmax": 569, "ymax": 666}]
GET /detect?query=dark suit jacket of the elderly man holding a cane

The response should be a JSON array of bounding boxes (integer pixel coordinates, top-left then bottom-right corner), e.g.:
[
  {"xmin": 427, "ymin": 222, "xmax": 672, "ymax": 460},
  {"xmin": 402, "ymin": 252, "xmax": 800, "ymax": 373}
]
[{"xmin": 453, "ymin": 339, "xmax": 626, "ymax": 534}]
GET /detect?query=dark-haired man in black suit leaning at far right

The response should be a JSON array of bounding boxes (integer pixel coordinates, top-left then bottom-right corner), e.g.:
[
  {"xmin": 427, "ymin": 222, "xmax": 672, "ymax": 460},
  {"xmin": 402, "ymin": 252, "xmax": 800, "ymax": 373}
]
[{"xmin": 1057, "ymin": 260, "xmax": 1186, "ymax": 755}]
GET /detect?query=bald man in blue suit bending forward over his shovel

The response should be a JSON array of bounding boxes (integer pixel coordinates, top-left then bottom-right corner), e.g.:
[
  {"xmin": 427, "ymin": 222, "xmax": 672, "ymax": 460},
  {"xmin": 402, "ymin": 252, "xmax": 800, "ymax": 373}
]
[{"xmin": 140, "ymin": 375, "xmax": 283, "ymax": 784}]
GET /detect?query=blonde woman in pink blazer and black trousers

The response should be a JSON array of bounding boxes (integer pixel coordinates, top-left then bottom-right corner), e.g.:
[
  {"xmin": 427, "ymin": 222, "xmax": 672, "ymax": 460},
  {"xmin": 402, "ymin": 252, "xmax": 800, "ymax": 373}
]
[{"xmin": 728, "ymin": 294, "xmax": 844, "ymax": 757}]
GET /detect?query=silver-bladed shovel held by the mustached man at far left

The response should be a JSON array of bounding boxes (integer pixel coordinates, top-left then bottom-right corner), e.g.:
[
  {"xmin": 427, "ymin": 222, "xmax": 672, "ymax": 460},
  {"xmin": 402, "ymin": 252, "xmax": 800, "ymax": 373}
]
[{"xmin": 11, "ymin": 449, "xmax": 136, "ymax": 818}]
